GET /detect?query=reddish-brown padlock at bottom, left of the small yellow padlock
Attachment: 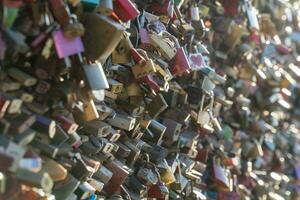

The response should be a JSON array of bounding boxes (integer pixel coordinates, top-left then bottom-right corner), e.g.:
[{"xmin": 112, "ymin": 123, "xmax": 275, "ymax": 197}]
[{"xmin": 104, "ymin": 160, "xmax": 129, "ymax": 194}]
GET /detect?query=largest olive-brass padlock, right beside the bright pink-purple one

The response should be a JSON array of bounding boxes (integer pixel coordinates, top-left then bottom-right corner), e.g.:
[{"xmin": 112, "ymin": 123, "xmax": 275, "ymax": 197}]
[{"xmin": 82, "ymin": 13, "xmax": 124, "ymax": 61}]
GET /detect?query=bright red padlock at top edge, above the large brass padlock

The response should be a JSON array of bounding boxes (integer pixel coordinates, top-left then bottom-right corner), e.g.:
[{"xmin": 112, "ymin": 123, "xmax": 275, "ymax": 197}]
[{"xmin": 114, "ymin": 0, "xmax": 140, "ymax": 22}]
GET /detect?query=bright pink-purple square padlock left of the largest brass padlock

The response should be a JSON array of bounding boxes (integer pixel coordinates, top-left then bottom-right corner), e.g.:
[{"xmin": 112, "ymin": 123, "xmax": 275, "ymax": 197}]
[{"xmin": 53, "ymin": 30, "xmax": 84, "ymax": 59}]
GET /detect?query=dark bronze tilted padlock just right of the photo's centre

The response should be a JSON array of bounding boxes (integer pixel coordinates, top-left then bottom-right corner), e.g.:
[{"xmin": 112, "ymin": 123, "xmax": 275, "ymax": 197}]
[{"xmin": 146, "ymin": 94, "xmax": 168, "ymax": 118}]
